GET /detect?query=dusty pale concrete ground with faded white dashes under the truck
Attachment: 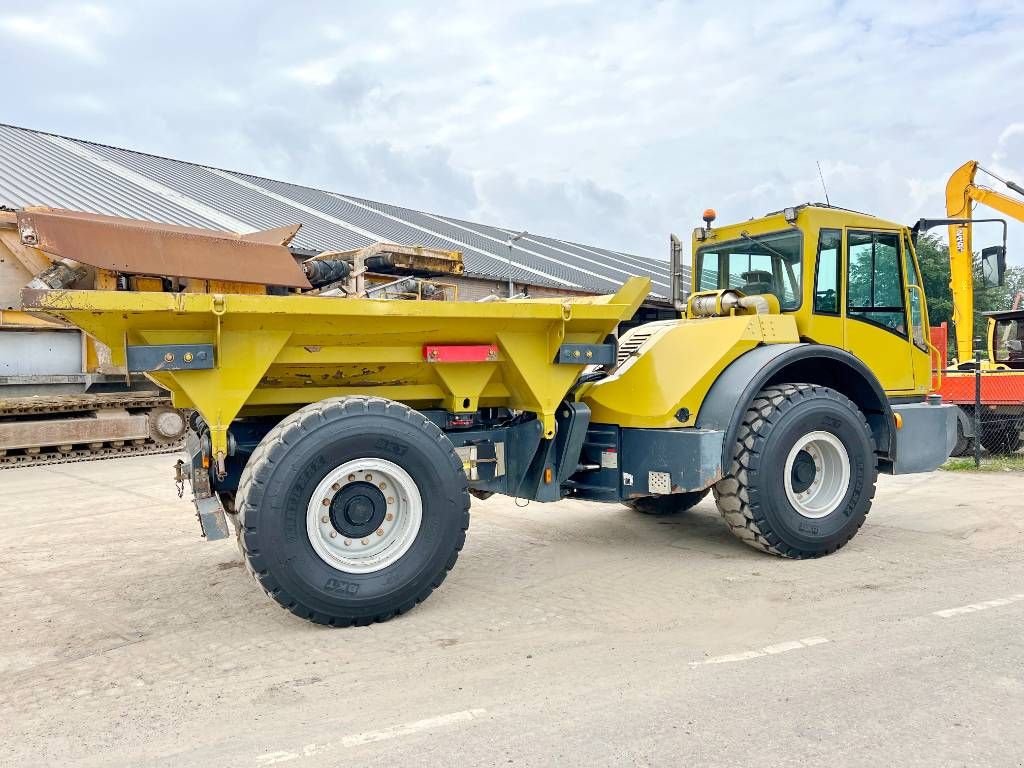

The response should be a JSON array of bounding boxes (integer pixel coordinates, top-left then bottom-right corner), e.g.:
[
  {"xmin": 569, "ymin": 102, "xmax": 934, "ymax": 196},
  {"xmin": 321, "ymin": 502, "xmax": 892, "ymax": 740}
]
[{"xmin": 0, "ymin": 456, "xmax": 1024, "ymax": 768}]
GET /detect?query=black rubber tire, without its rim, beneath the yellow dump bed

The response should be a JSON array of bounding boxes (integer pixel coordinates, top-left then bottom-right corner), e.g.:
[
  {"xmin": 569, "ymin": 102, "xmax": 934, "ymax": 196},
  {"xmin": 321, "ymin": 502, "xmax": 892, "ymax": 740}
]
[{"xmin": 238, "ymin": 397, "xmax": 470, "ymax": 627}]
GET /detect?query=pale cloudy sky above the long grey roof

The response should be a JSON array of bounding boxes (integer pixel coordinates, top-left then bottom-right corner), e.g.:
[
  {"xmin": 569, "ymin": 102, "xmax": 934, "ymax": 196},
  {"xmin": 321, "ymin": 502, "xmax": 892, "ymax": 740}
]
[{"xmin": 0, "ymin": 0, "xmax": 1024, "ymax": 264}]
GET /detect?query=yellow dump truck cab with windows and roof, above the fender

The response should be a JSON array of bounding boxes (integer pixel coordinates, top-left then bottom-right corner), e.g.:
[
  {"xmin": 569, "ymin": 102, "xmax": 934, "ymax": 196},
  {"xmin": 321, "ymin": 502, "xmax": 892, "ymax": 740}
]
[{"xmin": 692, "ymin": 205, "xmax": 932, "ymax": 397}]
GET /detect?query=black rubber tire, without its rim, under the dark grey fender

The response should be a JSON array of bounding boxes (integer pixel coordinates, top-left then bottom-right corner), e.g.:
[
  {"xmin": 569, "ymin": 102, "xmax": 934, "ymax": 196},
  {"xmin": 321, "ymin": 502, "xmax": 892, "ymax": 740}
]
[{"xmin": 714, "ymin": 384, "xmax": 878, "ymax": 559}]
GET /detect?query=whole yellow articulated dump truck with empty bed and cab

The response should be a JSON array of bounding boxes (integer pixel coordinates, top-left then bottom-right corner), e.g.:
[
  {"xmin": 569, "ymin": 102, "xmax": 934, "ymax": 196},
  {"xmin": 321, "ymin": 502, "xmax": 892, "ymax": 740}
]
[{"xmin": 23, "ymin": 205, "xmax": 956, "ymax": 626}]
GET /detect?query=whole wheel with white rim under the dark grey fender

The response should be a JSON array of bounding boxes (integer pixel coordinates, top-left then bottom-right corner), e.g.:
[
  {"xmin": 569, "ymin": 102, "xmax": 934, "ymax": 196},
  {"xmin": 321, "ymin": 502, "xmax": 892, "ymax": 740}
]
[{"xmin": 715, "ymin": 384, "xmax": 878, "ymax": 558}]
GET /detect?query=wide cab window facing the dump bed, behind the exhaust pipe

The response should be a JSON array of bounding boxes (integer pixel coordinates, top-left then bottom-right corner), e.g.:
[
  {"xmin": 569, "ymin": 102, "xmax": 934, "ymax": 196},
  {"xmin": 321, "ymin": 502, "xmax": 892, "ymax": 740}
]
[{"xmin": 696, "ymin": 229, "xmax": 803, "ymax": 309}]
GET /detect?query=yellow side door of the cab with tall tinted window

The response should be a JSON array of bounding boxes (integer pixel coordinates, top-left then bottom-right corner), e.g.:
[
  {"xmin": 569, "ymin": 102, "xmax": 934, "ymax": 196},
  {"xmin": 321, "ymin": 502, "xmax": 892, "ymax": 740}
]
[{"xmin": 844, "ymin": 228, "xmax": 920, "ymax": 392}]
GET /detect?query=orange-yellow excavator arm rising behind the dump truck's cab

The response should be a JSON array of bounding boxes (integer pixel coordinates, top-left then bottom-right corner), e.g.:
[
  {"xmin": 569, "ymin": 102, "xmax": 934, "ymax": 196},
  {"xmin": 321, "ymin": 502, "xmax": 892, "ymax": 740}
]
[{"xmin": 946, "ymin": 160, "xmax": 1024, "ymax": 362}]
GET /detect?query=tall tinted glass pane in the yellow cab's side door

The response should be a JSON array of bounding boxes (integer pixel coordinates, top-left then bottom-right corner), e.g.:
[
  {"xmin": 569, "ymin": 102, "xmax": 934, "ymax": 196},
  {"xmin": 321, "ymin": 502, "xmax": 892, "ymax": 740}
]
[{"xmin": 846, "ymin": 230, "xmax": 906, "ymax": 336}]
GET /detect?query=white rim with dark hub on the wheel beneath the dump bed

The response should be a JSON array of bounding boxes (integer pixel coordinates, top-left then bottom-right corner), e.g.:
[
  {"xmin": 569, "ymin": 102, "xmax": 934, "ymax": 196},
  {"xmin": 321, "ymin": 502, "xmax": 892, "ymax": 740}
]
[{"xmin": 306, "ymin": 459, "xmax": 423, "ymax": 573}]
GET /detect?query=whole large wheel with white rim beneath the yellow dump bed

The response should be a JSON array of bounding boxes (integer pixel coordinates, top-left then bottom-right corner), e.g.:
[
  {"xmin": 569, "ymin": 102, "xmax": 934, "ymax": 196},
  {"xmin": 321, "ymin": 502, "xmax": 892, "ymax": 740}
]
[{"xmin": 238, "ymin": 397, "xmax": 469, "ymax": 627}]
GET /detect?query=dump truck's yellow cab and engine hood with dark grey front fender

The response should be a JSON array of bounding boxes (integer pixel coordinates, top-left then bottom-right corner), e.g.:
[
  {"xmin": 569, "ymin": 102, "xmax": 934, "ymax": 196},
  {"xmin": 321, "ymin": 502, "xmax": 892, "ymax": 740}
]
[{"xmin": 581, "ymin": 205, "xmax": 949, "ymax": 483}]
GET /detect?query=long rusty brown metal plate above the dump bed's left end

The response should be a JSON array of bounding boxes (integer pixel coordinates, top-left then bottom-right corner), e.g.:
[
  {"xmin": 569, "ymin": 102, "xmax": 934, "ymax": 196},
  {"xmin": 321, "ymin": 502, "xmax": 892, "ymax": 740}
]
[{"xmin": 17, "ymin": 208, "xmax": 311, "ymax": 288}]
